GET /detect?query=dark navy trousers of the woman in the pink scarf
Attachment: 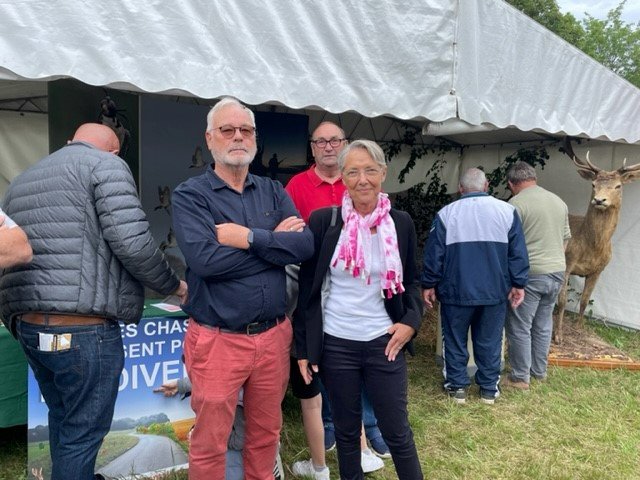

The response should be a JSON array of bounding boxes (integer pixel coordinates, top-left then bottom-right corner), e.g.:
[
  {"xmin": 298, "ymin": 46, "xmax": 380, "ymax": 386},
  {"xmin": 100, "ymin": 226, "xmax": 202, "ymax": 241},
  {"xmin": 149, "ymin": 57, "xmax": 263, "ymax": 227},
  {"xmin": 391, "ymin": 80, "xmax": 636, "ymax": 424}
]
[{"xmin": 320, "ymin": 334, "xmax": 423, "ymax": 480}]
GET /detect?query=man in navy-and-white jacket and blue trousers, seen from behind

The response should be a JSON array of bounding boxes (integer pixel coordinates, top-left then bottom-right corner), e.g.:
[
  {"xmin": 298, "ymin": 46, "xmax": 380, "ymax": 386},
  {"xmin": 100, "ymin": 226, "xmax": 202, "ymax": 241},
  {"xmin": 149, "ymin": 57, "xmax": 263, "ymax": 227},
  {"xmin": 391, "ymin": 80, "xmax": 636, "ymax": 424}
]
[{"xmin": 421, "ymin": 168, "xmax": 529, "ymax": 404}]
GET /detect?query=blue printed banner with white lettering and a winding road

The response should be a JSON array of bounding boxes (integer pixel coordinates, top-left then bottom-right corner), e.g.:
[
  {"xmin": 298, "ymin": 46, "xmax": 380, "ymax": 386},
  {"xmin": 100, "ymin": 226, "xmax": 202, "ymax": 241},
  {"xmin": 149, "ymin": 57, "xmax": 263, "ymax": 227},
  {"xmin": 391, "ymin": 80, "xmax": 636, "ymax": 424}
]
[{"xmin": 28, "ymin": 316, "xmax": 195, "ymax": 479}]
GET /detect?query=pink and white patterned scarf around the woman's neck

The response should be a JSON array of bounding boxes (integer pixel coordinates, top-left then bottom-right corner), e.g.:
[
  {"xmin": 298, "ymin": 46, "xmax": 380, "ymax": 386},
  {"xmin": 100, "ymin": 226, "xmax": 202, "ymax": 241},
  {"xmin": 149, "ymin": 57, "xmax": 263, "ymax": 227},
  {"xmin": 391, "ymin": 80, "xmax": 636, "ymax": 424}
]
[{"xmin": 332, "ymin": 192, "xmax": 404, "ymax": 298}]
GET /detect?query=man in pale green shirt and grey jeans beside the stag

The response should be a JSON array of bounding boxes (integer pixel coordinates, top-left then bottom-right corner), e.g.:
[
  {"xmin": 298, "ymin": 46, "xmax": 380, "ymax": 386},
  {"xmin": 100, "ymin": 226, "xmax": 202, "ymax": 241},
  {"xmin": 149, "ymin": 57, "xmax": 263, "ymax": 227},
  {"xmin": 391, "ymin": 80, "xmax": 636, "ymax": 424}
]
[{"xmin": 501, "ymin": 162, "xmax": 571, "ymax": 390}]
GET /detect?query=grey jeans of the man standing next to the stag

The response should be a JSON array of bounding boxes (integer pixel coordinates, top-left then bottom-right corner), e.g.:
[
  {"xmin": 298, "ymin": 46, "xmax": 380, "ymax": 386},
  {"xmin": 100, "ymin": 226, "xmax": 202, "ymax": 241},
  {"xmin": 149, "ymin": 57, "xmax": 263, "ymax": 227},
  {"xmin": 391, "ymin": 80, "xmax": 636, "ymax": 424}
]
[{"xmin": 505, "ymin": 272, "xmax": 564, "ymax": 383}]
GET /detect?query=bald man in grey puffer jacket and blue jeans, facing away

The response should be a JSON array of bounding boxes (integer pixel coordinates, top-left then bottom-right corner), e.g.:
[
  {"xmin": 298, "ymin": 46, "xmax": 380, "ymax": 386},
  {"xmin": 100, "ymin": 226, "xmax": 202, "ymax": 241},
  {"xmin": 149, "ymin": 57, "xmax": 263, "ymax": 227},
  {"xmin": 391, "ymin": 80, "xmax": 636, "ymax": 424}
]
[{"xmin": 0, "ymin": 123, "xmax": 187, "ymax": 480}]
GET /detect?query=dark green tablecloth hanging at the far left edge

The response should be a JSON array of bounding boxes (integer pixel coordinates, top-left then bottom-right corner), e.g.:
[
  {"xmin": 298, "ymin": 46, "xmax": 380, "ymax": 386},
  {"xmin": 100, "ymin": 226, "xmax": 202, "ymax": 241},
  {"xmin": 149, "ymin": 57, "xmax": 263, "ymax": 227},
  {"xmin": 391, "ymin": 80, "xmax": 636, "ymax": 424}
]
[{"xmin": 0, "ymin": 323, "xmax": 27, "ymax": 428}]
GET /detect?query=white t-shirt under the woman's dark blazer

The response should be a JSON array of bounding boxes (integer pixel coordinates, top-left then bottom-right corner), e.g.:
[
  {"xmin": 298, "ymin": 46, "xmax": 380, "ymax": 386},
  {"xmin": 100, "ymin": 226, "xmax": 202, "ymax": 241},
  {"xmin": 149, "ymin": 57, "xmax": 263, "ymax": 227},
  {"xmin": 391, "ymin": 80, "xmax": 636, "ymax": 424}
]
[{"xmin": 324, "ymin": 234, "xmax": 393, "ymax": 342}]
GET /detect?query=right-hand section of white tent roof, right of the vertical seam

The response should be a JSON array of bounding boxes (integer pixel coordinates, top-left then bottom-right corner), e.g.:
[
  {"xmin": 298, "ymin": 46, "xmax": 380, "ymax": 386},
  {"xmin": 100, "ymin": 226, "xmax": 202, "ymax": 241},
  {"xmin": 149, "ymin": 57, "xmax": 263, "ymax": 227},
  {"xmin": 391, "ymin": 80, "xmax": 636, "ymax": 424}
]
[{"xmin": 454, "ymin": 0, "xmax": 640, "ymax": 143}]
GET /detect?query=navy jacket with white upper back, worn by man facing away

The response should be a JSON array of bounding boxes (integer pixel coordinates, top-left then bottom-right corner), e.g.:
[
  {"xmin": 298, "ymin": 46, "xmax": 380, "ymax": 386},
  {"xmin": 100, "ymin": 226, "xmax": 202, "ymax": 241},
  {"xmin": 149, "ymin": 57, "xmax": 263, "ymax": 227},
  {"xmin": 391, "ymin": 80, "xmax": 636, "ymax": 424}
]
[{"xmin": 421, "ymin": 192, "xmax": 529, "ymax": 306}]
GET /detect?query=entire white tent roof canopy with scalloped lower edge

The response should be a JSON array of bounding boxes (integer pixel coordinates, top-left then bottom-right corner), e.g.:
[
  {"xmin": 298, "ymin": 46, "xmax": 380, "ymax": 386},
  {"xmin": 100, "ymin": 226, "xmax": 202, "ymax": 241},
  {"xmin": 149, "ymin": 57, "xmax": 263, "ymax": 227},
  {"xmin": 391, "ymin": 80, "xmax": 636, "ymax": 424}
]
[{"xmin": 0, "ymin": 0, "xmax": 640, "ymax": 143}]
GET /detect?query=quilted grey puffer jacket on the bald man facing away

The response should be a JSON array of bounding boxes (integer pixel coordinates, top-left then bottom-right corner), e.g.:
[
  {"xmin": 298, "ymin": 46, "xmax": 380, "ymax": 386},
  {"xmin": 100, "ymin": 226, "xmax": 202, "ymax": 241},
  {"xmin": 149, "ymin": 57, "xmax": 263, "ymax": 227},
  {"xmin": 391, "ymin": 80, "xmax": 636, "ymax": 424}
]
[{"xmin": 0, "ymin": 142, "xmax": 179, "ymax": 328}]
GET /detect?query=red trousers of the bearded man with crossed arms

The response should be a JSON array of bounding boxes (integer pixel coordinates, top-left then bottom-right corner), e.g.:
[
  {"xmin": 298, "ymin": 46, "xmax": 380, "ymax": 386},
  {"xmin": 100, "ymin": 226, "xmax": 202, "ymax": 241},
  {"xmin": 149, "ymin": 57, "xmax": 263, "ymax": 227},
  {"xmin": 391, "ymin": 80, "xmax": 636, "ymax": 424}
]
[{"xmin": 184, "ymin": 319, "xmax": 292, "ymax": 480}]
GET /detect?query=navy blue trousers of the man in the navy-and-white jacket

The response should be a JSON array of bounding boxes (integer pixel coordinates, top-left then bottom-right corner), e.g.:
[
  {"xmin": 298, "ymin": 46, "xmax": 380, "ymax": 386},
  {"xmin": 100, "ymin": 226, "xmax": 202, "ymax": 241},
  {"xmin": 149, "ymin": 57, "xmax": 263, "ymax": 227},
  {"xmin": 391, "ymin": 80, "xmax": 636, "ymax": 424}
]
[{"xmin": 440, "ymin": 302, "xmax": 507, "ymax": 396}]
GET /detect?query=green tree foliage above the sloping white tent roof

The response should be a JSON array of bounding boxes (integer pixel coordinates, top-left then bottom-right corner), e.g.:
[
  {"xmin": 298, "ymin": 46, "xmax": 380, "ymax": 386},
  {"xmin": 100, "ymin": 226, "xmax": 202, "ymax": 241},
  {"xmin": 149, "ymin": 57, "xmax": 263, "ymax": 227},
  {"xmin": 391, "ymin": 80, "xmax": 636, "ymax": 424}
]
[{"xmin": 507, "ymin": 0, "xmax": 640, "ymax": 87}]
